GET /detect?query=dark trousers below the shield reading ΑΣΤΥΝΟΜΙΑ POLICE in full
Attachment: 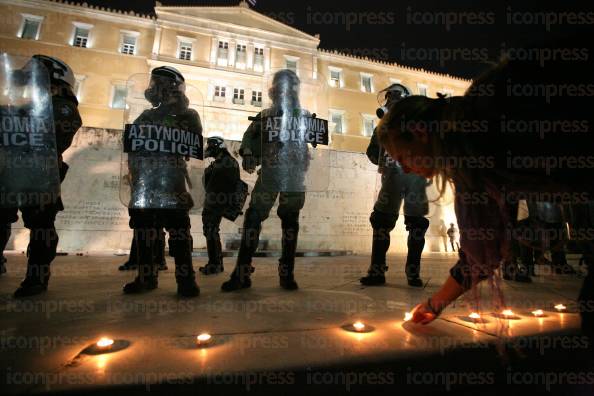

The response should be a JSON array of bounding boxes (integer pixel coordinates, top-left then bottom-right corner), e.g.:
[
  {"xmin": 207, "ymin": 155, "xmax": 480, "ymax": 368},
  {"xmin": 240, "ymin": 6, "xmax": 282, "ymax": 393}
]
[{"xmin": 128, "ymin": 209, "xmax": 194, "ymax": 280}]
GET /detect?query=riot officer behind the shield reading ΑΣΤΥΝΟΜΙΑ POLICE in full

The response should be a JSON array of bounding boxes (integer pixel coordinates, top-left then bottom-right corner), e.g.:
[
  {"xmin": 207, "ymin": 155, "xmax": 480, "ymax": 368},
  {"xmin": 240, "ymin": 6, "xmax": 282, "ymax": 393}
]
[{"xmin": 124, "ymin": 66, "xmax": 202, "ymax": 297}]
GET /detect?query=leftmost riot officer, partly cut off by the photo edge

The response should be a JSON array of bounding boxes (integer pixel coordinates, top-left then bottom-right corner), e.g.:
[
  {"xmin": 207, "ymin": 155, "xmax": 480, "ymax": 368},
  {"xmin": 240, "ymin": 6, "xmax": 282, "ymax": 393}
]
[{"xmin": 0, "ymin": 55, "xmax": 82, "ymax": 297}]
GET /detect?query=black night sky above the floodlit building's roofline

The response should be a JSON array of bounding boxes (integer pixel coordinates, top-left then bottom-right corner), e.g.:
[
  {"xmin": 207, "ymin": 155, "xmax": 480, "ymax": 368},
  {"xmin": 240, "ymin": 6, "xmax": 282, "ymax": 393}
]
[{"xmin": 86, "ymin": 0, "xmax": 594, "ymax": 78}]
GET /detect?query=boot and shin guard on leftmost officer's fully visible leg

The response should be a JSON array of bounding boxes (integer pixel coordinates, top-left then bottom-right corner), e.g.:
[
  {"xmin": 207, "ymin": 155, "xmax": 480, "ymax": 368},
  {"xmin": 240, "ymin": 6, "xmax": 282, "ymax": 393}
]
[{"xmin": 14, "ymin": 224, "xmax": 58, "ymax": 298}]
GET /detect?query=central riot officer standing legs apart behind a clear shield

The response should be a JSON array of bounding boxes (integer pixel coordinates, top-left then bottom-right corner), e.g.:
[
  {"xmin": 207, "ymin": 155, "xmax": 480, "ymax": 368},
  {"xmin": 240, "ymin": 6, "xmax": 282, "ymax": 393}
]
[{"xmin": 221, "ymin": 69, "xmax": 311, "ymax": 291}]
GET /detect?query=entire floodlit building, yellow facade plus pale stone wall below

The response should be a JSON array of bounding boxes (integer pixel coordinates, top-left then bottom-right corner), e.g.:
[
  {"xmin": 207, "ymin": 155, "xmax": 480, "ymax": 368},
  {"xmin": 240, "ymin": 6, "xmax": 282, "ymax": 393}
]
[{"xmin": 0, "ymin": 0, "xmax": 462, "ymax": 251}]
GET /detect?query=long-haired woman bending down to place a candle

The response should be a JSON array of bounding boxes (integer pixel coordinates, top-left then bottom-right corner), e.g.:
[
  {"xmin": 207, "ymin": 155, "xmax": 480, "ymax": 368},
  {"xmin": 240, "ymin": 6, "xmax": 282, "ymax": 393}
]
[{"xmin": 378, "ymin": 37, "xmax": 594, "ymax": 332}]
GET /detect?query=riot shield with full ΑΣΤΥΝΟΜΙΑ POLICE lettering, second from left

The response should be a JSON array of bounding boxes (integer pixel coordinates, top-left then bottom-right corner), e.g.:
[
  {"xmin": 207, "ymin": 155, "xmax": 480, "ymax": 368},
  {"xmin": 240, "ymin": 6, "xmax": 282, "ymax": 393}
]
[{"xmin": 120, "ymin": 74, "xmax": 204, "ymax": 209}]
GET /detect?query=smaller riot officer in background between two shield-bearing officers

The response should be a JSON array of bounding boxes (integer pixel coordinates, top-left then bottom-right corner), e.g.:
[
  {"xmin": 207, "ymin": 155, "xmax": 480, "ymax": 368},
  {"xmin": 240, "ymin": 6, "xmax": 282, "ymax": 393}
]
[{"xmin": 199, "ymin": 136, "xmax": 247, "ymax": 275}]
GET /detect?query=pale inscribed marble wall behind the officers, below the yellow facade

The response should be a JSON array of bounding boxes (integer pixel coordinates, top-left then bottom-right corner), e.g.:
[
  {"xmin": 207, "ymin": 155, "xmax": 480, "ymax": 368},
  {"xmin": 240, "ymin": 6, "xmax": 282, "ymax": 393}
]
[{"xmin": 7, "ymin": 128, "xmax": 455, "ymax": 254}]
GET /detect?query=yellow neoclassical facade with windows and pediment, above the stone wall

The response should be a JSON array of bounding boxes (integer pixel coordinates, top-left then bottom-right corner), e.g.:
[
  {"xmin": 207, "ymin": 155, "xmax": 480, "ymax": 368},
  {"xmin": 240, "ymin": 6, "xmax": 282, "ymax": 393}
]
[{"xmin": 0, "ymin": 0, "xmax": 470, "ymax": 152}]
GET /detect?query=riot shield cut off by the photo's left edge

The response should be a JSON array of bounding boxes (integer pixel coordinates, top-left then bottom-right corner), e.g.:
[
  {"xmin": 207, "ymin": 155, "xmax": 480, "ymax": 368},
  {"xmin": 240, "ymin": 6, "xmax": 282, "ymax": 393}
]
[{"xmin": 0, "ymin": 53, "xmax": 60, "ymax": 208}]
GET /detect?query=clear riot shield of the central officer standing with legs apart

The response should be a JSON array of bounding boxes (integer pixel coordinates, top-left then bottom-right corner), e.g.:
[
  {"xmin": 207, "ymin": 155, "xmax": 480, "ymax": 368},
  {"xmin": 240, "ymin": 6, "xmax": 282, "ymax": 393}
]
[{"xmin": 259, "ymin": 69, "xmax": 330, "ymax": 192}]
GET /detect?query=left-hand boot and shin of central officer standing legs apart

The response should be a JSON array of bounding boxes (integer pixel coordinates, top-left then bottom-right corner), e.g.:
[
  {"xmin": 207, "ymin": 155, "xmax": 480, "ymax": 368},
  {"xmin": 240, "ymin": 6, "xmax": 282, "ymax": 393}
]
[{"xmin": 221, "ymin": 208, "xmax": 262, "ymax": 292}]
